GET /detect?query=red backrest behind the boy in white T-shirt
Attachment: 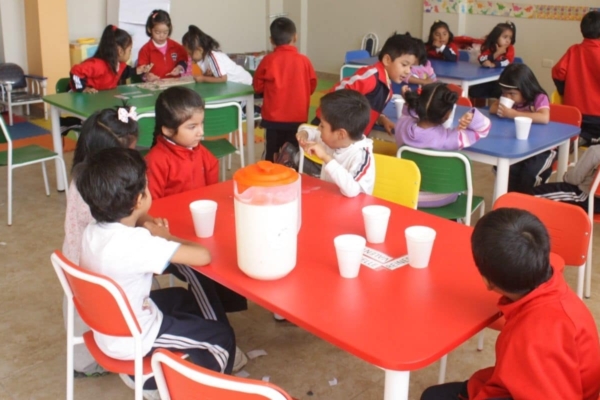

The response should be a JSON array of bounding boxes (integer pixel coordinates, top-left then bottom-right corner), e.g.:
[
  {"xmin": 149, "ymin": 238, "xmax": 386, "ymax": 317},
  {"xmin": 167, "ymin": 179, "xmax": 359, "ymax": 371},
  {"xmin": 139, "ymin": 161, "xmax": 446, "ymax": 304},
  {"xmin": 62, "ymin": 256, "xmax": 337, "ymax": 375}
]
[{"xmin": 50, "ymin": 250, "xmax": 141, "ymax": 338}]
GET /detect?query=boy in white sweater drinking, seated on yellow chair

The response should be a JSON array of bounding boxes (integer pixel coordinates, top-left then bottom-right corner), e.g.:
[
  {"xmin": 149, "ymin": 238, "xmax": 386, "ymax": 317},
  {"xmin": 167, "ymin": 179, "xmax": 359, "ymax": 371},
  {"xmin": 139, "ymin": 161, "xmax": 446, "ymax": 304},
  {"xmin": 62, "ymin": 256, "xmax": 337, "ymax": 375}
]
[{"xmin": 296, "ymin": 89, "xmax": 375, "ymax": 197}]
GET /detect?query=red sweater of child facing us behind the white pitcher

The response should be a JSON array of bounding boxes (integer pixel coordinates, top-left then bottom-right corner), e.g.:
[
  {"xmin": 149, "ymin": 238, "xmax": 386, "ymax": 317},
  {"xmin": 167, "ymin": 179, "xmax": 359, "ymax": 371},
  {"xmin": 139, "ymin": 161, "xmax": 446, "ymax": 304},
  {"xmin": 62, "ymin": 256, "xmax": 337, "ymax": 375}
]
[{"xmin": 146, "ymin": 136, "xmax": 219, "ymax": 199}]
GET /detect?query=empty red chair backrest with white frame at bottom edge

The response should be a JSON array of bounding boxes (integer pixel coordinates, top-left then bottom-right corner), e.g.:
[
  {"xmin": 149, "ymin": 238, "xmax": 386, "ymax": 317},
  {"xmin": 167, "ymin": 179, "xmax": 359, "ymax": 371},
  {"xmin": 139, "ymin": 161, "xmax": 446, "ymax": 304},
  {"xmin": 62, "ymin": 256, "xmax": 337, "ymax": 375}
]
[{"xmin": 152, "ymin": 349, "xmax": 292, "ymax": 400}]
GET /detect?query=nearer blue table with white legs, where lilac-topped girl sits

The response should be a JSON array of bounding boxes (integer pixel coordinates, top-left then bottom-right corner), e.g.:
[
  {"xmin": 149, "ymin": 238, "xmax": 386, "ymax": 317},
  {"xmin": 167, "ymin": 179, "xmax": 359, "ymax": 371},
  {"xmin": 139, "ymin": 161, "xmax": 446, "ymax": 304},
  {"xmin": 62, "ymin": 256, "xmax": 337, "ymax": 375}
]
[{"xmin": 384, "ymin": 102, "xmax": 580, "ymax": 201}]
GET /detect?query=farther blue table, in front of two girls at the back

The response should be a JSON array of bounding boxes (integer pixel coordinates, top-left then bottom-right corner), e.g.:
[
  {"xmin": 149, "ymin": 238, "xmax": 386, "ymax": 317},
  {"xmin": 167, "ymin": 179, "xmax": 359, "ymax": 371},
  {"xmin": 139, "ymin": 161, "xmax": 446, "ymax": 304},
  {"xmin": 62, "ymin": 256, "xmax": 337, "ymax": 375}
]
[{"xmin": 351, "ymin": 57, "xmax": 503, "ymax": 97}]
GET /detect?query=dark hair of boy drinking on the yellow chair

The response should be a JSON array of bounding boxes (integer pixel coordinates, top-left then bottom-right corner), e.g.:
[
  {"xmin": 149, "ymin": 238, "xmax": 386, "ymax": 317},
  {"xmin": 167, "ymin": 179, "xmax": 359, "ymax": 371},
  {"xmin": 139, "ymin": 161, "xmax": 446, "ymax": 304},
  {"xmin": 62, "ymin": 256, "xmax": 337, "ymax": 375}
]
[{"xmin": 321, "ymin": 89, "xmax": 371, "ymax": 140}]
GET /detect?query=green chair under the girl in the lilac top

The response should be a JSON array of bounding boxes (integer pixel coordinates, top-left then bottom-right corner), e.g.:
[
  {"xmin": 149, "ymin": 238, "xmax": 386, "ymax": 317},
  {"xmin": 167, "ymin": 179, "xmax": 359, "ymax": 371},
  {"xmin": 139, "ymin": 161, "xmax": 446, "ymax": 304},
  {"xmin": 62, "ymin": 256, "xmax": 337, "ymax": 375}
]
[{"xmin": 397, "ymin": 146, "xmax": 485, "ymax": 225}]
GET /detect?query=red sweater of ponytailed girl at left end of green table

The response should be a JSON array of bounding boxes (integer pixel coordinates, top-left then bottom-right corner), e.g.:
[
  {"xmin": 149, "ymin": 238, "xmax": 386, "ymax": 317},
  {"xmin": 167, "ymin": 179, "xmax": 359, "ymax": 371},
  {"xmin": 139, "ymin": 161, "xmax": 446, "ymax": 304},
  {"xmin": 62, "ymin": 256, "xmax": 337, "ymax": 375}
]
[{"xmin": 71, "ymin": 57, "xmax": 131, "ymax": 92}]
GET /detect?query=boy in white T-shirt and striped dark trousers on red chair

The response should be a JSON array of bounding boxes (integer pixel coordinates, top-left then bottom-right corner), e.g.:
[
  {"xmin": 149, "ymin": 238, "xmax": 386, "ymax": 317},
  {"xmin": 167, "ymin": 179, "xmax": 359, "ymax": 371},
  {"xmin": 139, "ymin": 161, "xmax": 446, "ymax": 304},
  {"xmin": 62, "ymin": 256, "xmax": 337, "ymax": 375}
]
[{"xmin": 76, "ymin": 148, "xmax": 235, "ymax": 398}]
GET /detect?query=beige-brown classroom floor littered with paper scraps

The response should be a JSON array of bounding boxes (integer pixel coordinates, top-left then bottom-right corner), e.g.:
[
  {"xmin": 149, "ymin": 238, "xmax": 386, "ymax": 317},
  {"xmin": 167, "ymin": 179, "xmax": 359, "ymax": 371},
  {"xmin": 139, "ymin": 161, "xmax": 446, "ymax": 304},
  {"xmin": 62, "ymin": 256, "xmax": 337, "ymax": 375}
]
[{"xmin": 0, "ymin": 109, "xmax": 600, "ymax": 400}]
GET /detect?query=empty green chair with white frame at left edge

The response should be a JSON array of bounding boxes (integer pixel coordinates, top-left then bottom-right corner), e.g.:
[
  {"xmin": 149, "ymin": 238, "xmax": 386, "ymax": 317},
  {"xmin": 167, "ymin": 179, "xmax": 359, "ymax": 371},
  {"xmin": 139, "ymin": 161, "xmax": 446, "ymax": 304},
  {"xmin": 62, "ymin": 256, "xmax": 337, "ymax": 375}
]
[{"xmin": 0, "ymin": 114, "xmax": 69, "ymax": 225}]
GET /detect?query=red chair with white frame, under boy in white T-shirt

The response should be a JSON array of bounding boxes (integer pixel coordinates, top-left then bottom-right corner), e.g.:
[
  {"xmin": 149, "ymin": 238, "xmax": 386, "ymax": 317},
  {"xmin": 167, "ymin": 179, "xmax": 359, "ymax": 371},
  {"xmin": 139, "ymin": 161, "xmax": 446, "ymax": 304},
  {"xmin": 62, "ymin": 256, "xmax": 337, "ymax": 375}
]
[{"xmin": 50, "ymin": 250, "xmax": 181, "ymax": 400}]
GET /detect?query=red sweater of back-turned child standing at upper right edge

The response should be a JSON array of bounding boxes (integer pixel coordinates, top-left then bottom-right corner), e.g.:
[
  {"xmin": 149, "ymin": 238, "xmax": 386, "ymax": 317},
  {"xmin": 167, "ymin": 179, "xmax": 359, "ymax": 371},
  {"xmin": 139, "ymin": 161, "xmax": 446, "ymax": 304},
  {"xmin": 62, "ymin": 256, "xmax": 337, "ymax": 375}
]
[{"xmin": 552, "ymin": 39, "xmax": 600, "ymax": 116}]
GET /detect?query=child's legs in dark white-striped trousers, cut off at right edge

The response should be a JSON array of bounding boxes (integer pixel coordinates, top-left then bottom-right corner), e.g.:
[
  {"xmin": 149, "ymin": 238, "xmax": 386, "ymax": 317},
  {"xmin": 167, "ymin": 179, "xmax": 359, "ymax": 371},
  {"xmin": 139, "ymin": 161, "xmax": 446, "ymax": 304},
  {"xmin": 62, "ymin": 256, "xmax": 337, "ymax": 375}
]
[{"xmin": 532, "ymin": 146, "xmax": 600, "ymax": 213}]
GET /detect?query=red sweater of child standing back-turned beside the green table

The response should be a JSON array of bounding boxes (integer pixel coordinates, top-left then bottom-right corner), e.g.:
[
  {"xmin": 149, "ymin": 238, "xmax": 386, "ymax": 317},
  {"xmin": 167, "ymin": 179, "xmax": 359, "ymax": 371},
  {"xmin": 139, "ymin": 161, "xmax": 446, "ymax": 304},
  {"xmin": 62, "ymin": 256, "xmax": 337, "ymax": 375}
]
[{"xmin": 252, "ymin": 45, "xmax": 317, "ymax": 123}]
